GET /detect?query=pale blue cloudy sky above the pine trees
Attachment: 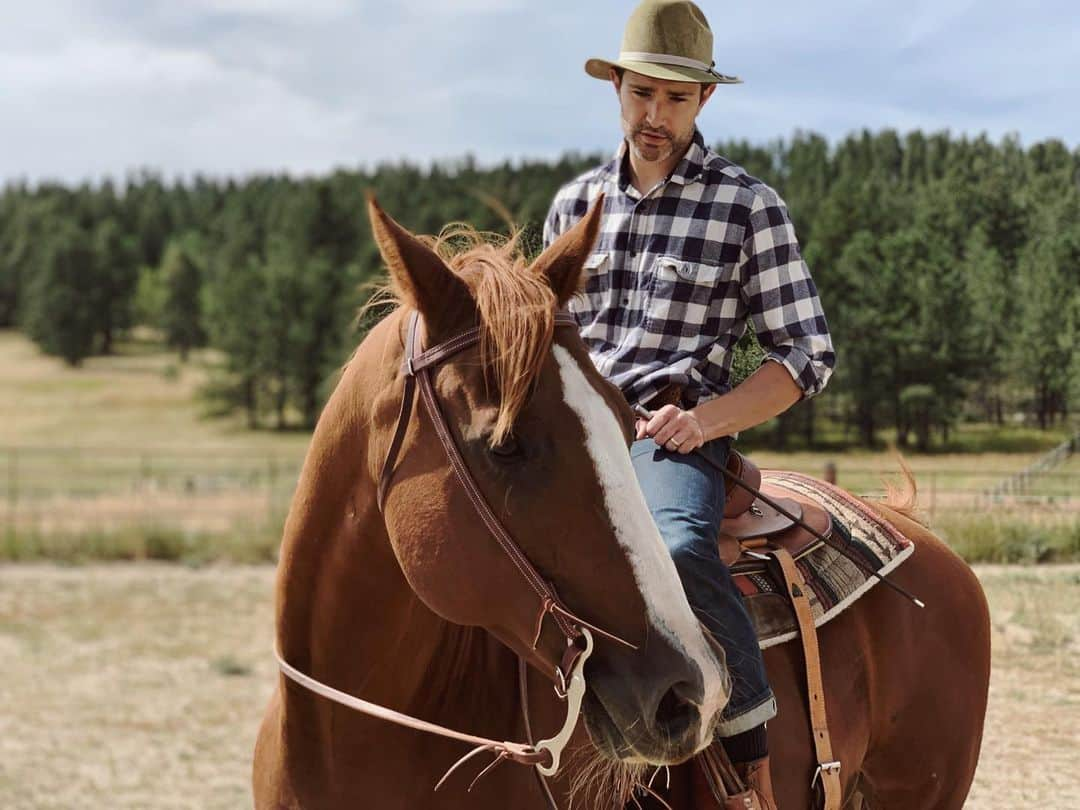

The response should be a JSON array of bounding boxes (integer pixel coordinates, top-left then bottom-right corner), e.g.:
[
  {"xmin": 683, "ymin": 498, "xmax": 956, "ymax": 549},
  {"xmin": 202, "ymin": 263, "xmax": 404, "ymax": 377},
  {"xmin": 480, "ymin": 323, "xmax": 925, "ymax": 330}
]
[{"xmin": 0, "ymin": 0, "xmax": 1080, "ymax": 181}]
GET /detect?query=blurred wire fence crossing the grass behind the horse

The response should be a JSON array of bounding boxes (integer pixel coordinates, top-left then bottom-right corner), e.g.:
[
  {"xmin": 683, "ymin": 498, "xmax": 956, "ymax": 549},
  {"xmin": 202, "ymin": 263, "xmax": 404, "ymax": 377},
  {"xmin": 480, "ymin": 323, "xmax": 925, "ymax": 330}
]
[{"xmin": 0, "ymin": 447, "xmax": 1080, "ymax": 552}]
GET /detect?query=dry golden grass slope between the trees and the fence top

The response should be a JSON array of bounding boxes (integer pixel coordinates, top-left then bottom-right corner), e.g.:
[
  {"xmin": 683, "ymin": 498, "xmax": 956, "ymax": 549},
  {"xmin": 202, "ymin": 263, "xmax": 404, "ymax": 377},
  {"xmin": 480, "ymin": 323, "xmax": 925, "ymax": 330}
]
[{"xmin": 0, "ymin": 329, "xmax": 1080, "ymax": 462}]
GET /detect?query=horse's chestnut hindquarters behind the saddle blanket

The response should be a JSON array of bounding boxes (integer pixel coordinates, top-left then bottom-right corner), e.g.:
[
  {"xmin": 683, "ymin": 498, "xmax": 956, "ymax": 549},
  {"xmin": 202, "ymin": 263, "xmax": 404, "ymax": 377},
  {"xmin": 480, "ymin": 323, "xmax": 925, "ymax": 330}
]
[{"xmin": 854, "ymin": 504, "xmax": 990, "ymax": 810}]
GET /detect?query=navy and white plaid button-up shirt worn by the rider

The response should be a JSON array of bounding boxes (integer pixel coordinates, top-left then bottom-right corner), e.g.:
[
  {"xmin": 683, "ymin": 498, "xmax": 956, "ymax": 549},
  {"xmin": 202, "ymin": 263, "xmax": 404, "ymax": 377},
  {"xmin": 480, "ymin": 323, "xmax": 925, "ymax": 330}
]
[{"xmin": 543, "ymin": 130, "xmax": 836, "ymax": 414}]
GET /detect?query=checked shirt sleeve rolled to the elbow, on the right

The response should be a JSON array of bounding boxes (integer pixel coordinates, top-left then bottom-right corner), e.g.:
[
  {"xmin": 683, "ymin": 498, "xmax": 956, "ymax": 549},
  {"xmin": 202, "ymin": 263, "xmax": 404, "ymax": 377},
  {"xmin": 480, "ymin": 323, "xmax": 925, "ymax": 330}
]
[{"xmin": 741, "ymin": 190, "xmax": 836, "ymax": 399}]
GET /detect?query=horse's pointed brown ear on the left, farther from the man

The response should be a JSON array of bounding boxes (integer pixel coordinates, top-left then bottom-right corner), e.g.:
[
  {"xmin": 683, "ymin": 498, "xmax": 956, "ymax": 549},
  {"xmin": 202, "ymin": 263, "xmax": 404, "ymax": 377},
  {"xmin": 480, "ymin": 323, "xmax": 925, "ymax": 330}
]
[{"xmin": 367, "ymin": 192, "xmax": 476, "ymax": 335}]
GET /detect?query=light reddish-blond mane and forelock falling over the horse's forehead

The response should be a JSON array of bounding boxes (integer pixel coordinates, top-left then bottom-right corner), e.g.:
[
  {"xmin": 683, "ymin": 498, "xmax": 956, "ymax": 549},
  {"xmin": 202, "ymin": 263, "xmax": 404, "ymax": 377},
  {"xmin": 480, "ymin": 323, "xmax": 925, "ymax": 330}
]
[{"xmin": 369, "ymin": 222, "xmax": 556, "ymax": 446}]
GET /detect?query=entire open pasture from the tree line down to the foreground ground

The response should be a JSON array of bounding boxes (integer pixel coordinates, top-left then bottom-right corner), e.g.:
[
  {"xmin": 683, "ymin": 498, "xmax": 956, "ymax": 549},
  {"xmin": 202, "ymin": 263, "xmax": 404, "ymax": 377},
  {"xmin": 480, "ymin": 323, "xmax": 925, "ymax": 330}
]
[{"xmin": 0, "ymin": 332, "xmax": 1080, "ymax": 810}]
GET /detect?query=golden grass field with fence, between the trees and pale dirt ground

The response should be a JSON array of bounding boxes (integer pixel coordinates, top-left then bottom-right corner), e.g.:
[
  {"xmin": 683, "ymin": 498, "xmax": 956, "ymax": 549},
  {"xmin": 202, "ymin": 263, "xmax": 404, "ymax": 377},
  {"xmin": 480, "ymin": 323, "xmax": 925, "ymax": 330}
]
[{"xmin": 0, "ymin": 330, "xmax": 1080, "ymax": 563}]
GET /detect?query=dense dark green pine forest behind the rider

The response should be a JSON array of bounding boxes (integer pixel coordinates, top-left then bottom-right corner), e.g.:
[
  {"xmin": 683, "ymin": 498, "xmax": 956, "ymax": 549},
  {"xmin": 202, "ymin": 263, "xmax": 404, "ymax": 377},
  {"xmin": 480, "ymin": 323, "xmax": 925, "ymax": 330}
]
[{"xmin": 0, "ymin": 131, "xmax": 1080, "ymax": 448}]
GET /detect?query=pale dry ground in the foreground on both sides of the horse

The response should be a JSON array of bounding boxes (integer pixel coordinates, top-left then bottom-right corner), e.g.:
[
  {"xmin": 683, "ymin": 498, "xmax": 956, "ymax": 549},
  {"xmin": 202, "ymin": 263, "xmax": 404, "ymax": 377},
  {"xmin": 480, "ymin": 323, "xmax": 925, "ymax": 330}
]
[{"xmin": 0, "ymin": 564, "xmax": 1080, "ymax": 810}]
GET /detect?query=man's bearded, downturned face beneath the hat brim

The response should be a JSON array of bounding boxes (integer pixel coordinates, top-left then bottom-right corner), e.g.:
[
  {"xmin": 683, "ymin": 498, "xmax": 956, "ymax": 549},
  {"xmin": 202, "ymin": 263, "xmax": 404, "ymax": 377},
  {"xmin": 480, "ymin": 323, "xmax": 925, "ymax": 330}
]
[{"xmin": 611, "ymin": 70, "xmax": 716, "ymax": 162}]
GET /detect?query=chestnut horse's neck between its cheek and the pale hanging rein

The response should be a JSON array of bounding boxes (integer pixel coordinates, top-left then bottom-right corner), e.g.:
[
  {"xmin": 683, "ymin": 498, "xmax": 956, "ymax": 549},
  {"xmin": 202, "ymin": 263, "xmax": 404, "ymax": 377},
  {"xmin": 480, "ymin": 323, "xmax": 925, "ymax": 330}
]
[{"xmin": 278, "ymin": 319, "xmax": 519, "ymax": 739}]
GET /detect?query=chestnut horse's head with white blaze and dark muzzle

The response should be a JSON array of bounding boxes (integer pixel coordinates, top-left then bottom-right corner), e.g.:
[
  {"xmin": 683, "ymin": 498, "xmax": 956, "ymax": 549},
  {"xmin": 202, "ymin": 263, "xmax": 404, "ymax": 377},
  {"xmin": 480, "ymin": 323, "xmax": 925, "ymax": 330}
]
[{"xmin": 368, "ymin": 199, "xmax": 729, "ymax": 764}]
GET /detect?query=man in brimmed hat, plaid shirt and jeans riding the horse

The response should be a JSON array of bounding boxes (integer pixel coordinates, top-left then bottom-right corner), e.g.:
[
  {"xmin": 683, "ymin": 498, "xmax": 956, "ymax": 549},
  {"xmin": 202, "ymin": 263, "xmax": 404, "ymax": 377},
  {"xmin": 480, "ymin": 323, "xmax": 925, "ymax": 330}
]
[{"xmin": 544, "ymin": 0, "xmax": 835, "ymax": 808}]
